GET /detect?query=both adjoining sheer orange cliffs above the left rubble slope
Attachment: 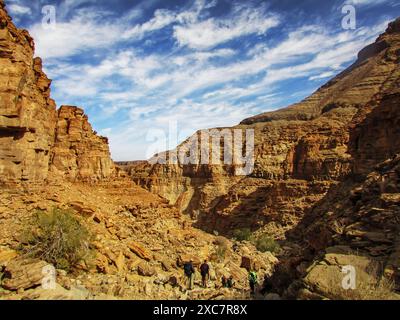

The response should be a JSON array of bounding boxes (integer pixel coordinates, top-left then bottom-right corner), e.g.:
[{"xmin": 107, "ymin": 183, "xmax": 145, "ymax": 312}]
[{"xmin": 0, "ymin": 1, "xmax": 114, "ymax": 186}]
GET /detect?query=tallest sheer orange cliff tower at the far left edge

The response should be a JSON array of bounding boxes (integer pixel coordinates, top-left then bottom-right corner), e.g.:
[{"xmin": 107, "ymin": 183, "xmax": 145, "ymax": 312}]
[{"xmin": 0, "ymin": 3, "xmax": 56, "ymax": 185}]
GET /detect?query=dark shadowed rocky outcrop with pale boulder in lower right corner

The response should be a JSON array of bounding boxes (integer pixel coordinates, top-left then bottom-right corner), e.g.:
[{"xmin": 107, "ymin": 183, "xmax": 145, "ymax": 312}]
[{"xmin": 287, "ymin": 156, "xmax": 400, "ymax": 299}]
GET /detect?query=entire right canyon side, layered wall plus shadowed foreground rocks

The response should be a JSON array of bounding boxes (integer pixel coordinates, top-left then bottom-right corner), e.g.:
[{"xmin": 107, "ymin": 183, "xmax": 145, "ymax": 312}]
[{"xmin": 124, "ymin": 19, "xmax": 400, "ymax": 299}]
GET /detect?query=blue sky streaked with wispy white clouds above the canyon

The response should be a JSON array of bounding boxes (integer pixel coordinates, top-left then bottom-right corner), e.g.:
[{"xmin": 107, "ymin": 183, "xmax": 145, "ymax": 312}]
[{"xmin": 6, "ymin": 0, "xmax": 400, "ymax": 161}]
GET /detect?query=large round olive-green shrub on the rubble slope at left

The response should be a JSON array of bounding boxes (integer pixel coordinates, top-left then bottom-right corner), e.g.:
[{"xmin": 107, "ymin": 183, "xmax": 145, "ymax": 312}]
[{"xmin": 23, "ymin": 209, "xmax": 91, "ymax": 271}]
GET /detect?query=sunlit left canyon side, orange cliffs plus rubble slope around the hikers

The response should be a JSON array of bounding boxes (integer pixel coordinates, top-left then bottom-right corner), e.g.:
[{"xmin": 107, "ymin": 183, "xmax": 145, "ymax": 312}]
[{"xmin": 0, "ymin": 0, "xmax": 277, "ymax": 299}]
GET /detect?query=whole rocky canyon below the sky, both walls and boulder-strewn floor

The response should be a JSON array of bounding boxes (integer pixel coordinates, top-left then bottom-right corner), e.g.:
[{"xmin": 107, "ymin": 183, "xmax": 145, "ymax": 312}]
[{"xmin": 0, "ymin": 0, "xmax": 400, "ymax": 299}]
